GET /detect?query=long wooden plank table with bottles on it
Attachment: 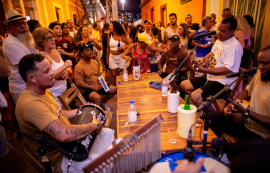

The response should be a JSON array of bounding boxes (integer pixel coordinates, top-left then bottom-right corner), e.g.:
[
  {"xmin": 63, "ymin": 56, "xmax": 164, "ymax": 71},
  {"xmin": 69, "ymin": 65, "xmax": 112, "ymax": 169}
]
[{"xmin": 117, "ymin": 73, "xmax": 216, "ymax": 151}]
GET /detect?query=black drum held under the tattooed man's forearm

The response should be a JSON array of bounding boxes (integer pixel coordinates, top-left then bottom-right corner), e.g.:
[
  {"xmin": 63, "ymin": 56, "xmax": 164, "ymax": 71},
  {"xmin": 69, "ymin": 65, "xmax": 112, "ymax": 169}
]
[{"xmin": 61, "ymin": 103, "xmax": 106, "ymax": 161}]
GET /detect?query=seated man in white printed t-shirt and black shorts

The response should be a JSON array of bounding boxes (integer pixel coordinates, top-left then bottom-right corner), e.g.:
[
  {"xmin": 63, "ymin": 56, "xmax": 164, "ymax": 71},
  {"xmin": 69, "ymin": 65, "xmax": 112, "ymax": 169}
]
[{"xmin": 180, "ymin": 17, "xmax": 243, "ymax": 106}]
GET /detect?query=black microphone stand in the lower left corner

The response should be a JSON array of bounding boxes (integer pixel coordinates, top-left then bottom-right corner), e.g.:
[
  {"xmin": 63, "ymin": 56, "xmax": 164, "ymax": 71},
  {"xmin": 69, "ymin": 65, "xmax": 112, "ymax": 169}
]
[{"xmin": 0, "ymin": 121, "xmax": 70, "ymax": 173}]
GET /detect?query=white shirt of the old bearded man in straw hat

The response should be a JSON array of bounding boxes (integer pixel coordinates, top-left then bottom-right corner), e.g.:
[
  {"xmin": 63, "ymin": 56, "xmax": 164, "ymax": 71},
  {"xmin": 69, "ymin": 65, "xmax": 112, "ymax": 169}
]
[{"xmin": 2, "ymin": 34, "xmax": 37, "ymax": 94}]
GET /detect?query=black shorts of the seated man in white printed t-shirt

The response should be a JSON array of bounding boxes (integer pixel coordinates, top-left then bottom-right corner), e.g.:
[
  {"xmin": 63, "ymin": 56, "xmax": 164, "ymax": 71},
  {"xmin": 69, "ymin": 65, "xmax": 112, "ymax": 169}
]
[{"xmin": 189, "ymin": 77, "xmax": 231, "ymax": 101}]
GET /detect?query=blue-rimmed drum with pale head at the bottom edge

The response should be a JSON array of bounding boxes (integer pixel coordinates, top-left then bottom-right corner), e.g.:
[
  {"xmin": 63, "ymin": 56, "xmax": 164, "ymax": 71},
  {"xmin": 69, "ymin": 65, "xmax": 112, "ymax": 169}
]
[{"xmin": 149, "ymin": 151, "xmax": 231, "ymax": 173}]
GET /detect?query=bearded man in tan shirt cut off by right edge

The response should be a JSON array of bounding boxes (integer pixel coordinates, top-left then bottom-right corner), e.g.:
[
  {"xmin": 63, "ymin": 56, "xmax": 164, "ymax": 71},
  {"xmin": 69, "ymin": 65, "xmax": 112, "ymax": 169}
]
[{"xmin": 208, "ymin": 46, "xmax": 270, "ymax": 140}]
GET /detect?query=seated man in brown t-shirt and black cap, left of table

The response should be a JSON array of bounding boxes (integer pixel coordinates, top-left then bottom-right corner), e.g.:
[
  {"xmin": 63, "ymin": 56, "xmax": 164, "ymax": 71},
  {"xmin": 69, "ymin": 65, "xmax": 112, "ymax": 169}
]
[{"xmin": 74, "ymin": 44, "xmax": 116, "ymax": 111}]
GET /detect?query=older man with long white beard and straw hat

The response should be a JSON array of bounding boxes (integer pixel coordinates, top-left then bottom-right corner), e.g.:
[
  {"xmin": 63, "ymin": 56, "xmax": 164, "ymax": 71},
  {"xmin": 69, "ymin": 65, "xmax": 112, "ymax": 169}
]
[{"xmin": 2, "ymin": 10, "xmax": 36, "ymax": 103}]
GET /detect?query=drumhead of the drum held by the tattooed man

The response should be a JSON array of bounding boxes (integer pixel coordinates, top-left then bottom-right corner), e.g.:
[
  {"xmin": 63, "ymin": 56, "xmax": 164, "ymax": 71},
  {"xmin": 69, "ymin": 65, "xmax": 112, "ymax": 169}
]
[{"xmin": 74, "ymin": 103, "xmax": 106, "ymax": 125}]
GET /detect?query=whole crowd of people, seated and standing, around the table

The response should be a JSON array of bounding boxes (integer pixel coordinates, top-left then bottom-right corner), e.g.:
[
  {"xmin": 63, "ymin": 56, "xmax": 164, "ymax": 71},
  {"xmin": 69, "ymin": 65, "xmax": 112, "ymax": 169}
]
[{"xmin": 0, "ymin": 8, "xmax": 270, "ymax": 172}]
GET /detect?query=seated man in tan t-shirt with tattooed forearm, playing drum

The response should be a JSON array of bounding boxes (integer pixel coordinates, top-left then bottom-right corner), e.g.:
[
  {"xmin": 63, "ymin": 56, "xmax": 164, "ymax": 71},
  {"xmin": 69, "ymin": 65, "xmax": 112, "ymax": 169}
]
[{"xmin": 15, "ymin": 54, "xmax": 111, "ymax": 172}]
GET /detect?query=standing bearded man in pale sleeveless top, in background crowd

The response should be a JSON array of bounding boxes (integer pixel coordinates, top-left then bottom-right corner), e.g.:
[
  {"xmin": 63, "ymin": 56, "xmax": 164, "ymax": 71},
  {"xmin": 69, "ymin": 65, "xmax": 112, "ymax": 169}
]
[{"xmin": 164, "ymin": 13, "xmax": 178, "ymax": 44}]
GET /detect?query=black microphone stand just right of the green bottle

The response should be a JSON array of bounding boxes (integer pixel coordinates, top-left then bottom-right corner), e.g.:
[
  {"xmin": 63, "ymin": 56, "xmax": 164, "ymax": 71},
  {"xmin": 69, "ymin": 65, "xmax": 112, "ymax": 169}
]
[{"xmin": 197, "ymin": 74, "xmax": 240, "ymax": 153}]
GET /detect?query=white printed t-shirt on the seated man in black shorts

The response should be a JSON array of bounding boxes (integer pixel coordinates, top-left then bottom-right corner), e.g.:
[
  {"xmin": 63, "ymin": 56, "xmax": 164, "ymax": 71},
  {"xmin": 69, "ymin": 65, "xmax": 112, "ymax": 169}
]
[{"xmin": 207, "ymin": 37, "xmax": 243, "ymax": 90}]
